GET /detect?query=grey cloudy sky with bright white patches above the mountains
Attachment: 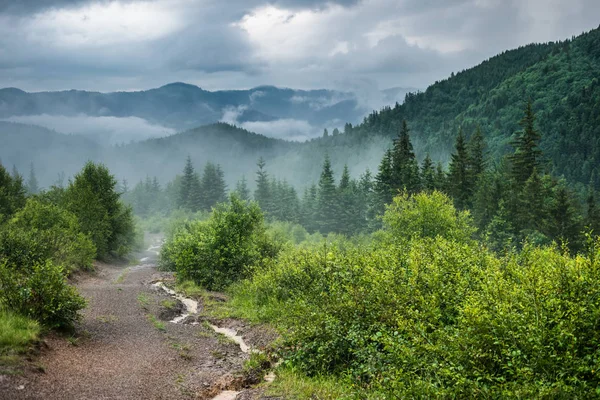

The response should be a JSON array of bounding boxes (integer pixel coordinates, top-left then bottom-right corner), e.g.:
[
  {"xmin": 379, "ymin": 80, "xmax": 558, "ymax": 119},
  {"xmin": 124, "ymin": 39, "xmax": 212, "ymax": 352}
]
[{"xmin": 0, "ymin": 0, "xmax": 600, "ymax": 93}]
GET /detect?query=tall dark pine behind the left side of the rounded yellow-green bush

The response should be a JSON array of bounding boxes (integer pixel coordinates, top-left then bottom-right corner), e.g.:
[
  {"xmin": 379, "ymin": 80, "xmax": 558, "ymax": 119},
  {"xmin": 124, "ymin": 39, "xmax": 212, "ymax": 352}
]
[{"xmin": 391, "ymin": 120, "xmax": 420, "ymax": 193}]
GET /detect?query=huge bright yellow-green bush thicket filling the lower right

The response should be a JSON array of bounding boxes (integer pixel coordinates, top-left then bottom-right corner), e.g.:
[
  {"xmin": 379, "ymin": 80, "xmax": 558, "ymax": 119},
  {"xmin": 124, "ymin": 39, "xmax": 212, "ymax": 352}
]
[{"xmin": 232, "ymin": 194, "xmax": 600, "ymax": 398}]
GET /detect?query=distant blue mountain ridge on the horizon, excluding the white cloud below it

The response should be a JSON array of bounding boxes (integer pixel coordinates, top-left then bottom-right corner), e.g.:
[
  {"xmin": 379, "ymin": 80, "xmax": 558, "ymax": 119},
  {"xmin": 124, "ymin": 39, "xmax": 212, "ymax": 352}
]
[{"xmin": 0, "ymin": 83, "xmax": 369, "ymax": 133}]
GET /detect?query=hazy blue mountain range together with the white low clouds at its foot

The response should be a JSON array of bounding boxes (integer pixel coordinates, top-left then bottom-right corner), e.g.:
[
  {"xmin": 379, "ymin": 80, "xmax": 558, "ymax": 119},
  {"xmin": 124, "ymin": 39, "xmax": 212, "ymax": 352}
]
[{"xmin": 0, "ymin": 83, "xmax": 412, "ymax": 143}]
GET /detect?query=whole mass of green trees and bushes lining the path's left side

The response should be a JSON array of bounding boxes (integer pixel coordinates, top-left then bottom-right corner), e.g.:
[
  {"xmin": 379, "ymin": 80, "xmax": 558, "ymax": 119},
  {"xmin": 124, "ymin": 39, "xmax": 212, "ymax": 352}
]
[{"xmin": 0, "ymin": 162, "xmax": 139, "ymax": 336}]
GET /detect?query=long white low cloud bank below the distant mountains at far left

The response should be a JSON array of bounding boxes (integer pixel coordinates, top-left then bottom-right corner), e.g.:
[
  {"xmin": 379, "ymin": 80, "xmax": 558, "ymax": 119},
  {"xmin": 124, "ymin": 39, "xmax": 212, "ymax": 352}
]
[{"xmin": 5, "ymin": 114, "xmax": 176, "ymax": 144}]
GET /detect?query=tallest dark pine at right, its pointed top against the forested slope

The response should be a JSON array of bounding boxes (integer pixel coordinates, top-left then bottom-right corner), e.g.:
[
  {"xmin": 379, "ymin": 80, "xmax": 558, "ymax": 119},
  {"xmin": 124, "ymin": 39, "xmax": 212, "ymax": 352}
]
[{"xmin": 509, "ymin": 101, "xmax": 542, "ymax": 185}]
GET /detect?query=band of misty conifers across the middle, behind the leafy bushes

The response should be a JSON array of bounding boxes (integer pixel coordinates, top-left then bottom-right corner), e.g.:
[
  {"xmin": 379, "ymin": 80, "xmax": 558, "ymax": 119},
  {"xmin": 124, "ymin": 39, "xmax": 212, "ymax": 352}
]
[{"xmin": 126, "ymin": 103, "xmax": 600, "ymax": 255}]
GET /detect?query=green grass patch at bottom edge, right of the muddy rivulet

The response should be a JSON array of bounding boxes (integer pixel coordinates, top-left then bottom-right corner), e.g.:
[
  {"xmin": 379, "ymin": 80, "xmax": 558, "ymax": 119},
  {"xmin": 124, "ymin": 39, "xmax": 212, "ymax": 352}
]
[{"xmin": 265, "ymin": 368, "xmax": 356, "ymax": 400}]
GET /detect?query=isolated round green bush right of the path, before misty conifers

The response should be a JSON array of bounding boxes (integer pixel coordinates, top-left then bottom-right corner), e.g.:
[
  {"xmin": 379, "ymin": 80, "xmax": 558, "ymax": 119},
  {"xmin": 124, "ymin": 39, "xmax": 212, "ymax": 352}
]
[{"xmin": 161, "ymin": 195, "xmax": 277, "ymax": 290}]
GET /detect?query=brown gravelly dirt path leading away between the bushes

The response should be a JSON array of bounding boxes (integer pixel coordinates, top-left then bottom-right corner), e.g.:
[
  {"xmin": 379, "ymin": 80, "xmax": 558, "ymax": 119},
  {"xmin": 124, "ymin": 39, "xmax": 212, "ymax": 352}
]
[{"xmin": 0, "ymin": 237, "xmax": 255, "ymax": 399}]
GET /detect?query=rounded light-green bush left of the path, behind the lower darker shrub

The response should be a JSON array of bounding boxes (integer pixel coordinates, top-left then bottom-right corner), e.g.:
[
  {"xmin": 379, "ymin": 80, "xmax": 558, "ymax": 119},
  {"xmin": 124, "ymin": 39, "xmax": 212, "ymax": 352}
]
[{"xmin": 7, "ymin": 199, "xmax": 96, "ymax": 272}]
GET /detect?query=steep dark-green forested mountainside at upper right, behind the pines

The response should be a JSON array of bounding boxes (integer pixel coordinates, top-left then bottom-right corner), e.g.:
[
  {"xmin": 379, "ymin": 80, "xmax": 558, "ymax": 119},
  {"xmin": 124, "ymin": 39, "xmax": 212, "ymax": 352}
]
[{"xmin": 338, "ymin": 29, "xmax": 600, "ymax": 188}]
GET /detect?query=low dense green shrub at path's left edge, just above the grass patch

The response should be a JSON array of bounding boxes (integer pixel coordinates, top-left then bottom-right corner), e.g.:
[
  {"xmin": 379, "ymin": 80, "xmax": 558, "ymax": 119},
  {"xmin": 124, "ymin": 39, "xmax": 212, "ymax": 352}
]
[{"xmin": 0, "ymin": 260, "xmax": 85, "ymax": 327}]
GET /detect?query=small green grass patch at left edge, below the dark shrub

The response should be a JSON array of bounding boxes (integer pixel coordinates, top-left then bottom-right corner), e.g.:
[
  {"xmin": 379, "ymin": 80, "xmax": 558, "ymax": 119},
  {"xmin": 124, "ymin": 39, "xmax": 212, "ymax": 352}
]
[{"xmin": 0, "ymin": 309, "xmax": 41, "ymax": 373}]
